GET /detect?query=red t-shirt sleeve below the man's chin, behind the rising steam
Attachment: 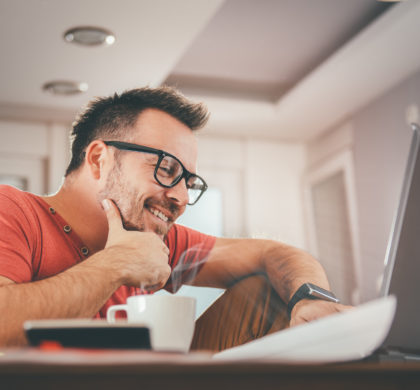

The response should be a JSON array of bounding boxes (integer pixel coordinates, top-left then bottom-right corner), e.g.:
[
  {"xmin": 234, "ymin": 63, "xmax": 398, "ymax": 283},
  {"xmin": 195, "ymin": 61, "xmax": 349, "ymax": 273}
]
[{"xmin": 165, "ymin": 225, "xmax": 216, "ymax": 292}]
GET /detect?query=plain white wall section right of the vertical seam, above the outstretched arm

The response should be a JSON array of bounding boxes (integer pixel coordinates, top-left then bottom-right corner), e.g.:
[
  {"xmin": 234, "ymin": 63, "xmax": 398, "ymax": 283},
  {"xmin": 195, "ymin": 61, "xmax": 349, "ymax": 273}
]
[{"xmin": 245, "ymin": 140, "xmax": 306, "ymax": 248}]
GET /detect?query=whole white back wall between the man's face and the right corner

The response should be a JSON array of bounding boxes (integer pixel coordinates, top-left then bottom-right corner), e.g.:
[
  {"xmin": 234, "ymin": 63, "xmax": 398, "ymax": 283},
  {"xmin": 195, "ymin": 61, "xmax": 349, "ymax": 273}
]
[{"xmin": 198, "ymin": 131, "xmax": 306, "ymax": 248}]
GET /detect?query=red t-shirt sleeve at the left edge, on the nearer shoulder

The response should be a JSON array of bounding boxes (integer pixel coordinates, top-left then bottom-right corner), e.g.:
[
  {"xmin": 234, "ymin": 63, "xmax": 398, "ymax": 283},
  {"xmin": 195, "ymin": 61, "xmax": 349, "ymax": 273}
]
[{"xmin": 0, "ymin": 188, "xmax": 34, "ymax": 283}]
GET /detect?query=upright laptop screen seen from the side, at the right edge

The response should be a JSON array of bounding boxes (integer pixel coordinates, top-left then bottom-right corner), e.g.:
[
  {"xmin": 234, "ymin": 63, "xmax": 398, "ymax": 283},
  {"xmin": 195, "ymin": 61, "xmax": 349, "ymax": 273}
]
[{"xmin": 381, "ymin": 124, "xmax": 420, "ymax": 350}]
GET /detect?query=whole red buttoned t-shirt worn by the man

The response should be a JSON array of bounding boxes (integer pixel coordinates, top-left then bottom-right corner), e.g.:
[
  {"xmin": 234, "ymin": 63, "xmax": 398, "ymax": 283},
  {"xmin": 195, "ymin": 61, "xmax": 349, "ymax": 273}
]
[{"xmin": 0, "ymin": 185, "xmax": 216, "ymax": 317}]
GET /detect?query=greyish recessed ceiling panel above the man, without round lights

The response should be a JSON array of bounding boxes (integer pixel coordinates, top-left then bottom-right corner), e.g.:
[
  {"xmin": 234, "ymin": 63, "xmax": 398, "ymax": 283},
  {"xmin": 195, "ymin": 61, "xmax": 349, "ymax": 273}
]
[{"xmin": 167, "ymin": 0, "xmax": 390, "ymax": 102}]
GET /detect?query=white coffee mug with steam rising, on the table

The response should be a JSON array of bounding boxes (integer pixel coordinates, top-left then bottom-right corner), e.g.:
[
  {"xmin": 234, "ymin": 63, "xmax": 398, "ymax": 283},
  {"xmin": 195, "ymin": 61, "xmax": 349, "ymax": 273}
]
[{"xmin": 107, "ymin": 295, "xmax": 196, "ymax": 352}]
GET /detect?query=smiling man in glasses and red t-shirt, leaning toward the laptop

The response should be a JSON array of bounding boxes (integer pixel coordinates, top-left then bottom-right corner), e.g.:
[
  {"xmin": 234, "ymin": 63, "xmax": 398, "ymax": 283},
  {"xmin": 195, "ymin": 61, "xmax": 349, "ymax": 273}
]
[{"xmin": 0, "ymin": 88, "xmax": 343, "ymax": 345}]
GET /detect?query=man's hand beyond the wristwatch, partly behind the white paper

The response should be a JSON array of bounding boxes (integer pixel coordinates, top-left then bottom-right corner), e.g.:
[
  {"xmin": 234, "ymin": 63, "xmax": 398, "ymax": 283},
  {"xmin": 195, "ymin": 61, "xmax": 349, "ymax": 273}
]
[{"xmin": 290, "ymin": 299, "xmax": 353, "ymax": 327}]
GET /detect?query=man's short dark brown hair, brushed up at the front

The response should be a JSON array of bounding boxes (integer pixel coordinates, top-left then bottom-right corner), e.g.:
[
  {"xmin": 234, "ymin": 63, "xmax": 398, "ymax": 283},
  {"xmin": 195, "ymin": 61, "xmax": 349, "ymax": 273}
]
[{"xmin": 65, "ymin": 87, "xmax": 209, "ymax": 176}]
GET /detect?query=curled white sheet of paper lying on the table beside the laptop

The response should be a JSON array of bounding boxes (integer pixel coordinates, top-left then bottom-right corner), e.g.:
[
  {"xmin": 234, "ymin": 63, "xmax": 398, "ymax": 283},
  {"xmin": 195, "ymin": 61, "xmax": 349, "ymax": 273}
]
[{"xmin": 213, "ymin": 296, "xmax": 396, "ymax": 363}]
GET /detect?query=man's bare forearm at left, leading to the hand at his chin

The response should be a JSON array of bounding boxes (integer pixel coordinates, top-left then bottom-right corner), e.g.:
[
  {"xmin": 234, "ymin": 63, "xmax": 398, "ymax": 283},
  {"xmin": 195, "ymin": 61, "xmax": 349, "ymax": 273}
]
[{"xmin": 0, "ymin": 251, "xmax": 121, "ymax": 345}]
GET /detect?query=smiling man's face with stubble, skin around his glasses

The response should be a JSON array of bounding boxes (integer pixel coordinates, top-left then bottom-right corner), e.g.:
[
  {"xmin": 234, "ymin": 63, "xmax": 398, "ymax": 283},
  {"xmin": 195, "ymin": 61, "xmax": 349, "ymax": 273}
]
[{"xmin": 99, "ymin": 109, "xmax": 197, "ymax": 238}]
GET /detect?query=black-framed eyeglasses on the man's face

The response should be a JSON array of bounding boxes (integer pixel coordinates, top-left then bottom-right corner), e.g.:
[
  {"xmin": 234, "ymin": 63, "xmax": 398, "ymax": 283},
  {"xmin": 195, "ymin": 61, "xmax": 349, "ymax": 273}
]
[{"xmin": 103, "ymin": 141, "xmax": 208, "ymax": 205}]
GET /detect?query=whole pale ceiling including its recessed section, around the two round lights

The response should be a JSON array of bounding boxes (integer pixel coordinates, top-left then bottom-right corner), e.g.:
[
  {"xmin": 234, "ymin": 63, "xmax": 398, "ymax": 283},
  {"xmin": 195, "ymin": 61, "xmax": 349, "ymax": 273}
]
[{"xmin": 0, "ymin": 0, "xmax": 420, "ymax": 141}]
